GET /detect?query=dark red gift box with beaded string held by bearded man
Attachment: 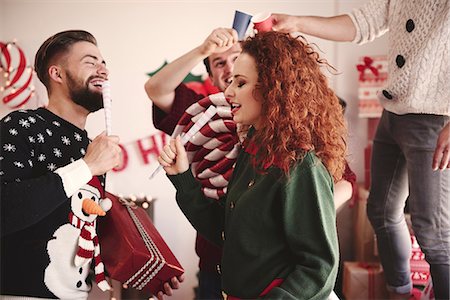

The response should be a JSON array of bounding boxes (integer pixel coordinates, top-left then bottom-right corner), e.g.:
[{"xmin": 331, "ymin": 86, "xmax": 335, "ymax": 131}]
[{"xmin": 98, "ymin": 193, "xmax": 184, "ymax": 295}]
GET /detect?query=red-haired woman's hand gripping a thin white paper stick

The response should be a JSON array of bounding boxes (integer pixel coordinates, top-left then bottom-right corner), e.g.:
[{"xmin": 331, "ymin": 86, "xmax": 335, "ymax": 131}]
[{"xmin": 158, "ymin": 136, "xmax": 189, "ymax": 175}]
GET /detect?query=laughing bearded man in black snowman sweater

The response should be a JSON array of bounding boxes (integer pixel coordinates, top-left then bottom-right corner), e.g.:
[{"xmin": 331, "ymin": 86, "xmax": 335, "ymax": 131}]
[{"xmin": 0, "ymin": 30, "xmax": 183, "ymax": 299}]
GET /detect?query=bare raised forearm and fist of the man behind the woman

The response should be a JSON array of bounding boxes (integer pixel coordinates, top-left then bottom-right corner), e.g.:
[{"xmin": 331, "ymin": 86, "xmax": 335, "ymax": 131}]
[{"xmin": 145, "ymin": 28, "xmax": 238, "ymax": 113}]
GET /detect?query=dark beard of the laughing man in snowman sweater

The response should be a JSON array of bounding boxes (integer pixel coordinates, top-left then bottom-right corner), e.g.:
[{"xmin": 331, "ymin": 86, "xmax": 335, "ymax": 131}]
[{"xmin": 66, "ymin": 72, "xmax": 103, "ymax": 112}]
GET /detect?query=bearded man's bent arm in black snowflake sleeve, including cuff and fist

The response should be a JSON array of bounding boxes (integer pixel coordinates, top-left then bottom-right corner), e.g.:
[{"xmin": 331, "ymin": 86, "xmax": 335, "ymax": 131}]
[{"xmin": 0, "ymin": 113, "xmax": 120, "ymax": 236}]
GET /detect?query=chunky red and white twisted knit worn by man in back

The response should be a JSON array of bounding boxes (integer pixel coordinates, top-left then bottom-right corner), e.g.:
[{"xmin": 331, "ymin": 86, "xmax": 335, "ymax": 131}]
[{"xmin": 173, "ymin": 93, "xmax": 240, "ymax": 199}]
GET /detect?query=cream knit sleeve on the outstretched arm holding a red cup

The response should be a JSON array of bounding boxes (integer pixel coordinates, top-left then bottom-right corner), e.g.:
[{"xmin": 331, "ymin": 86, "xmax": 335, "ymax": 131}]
[{"xmin": 348, "ymin": 0, "xmax": 390, "ymax": 44}]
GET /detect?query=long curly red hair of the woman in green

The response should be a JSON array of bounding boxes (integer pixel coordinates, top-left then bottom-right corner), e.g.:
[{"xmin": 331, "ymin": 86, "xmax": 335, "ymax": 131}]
[{"xmin": 242, "ymin": 31, "xmax": 347, "ymax": 181}]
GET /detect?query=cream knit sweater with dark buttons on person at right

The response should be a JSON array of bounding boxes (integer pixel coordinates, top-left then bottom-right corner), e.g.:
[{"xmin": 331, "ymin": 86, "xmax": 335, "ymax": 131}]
[{"xmin": 349, "ymin": 0, "xmax": 450, "ymax": 115}]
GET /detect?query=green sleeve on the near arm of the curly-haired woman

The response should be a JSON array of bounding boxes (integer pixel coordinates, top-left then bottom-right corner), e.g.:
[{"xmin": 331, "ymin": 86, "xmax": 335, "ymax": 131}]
[{"xmin": 266, "ymin": 154, "xmax": 339, "ymax": 300}]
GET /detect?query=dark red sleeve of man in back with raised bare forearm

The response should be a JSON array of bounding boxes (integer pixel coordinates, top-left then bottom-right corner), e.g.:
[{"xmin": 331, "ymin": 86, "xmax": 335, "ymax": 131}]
[{"xmin": 153, "ymin": 83, "xmax": 205, "ymax": 135}]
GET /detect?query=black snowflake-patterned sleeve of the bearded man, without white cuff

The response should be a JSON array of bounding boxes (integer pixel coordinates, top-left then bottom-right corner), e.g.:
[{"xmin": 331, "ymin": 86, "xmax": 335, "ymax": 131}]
[{"xmin": 0, "ymin": 112, "xmax": 67, "ymax": 236}]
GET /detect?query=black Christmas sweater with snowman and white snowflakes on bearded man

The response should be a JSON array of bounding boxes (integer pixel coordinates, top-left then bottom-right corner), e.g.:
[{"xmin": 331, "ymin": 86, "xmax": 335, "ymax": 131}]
[{"xmin": 0, "ymin": 108, "xmax": 108, "ymax": 299}]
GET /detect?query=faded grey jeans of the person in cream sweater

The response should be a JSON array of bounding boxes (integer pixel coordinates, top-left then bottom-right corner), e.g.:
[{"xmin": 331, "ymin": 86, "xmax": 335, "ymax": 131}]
[{"xmin": 367, "ymin": 111, "xmax": 450, "ymax": 299}]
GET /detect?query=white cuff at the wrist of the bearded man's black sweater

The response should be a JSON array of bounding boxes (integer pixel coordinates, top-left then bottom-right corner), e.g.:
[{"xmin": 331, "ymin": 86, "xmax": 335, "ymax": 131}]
[{"xmin": 55, "ymin": 158, "xmax": 92, "ymax": 197}]
